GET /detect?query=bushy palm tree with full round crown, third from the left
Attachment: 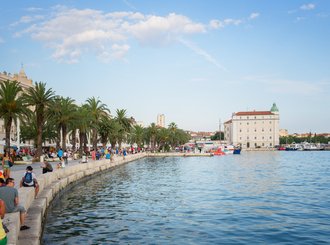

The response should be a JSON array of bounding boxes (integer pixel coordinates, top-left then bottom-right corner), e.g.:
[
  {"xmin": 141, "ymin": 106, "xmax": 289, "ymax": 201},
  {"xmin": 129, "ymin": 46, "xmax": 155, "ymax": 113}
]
[{"xmin": 49, "ymin": 96, "xmax": 77, "ymax": 150}]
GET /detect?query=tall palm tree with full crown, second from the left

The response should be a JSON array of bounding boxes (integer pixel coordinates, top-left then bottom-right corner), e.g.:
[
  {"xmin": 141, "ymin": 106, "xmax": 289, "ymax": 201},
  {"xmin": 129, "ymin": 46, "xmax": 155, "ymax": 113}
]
[{"xmin": 24, "ymin": 82, "xmax": 54, "ymax": 157}]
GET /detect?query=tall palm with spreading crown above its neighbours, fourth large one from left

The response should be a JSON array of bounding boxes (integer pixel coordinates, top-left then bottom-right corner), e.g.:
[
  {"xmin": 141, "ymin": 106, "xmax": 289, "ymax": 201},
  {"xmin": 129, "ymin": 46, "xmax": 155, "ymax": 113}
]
[{"xmin": 86, "ymin": 97, "xmax": 110, "ymax": 149}]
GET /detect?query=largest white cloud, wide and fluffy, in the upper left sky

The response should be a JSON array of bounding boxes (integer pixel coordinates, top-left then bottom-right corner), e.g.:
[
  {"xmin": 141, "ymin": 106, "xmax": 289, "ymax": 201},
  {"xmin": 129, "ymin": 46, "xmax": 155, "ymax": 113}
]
[{"xmin": 15, "ymin": 8, "xmax": 205, "ymax": 63}]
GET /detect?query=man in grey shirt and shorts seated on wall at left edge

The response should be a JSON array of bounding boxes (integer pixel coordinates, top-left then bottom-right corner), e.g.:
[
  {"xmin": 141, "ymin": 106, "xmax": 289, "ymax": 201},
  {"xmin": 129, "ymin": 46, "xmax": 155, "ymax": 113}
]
[{"xmin": 0, "ymin": 178, "xmax": 30, "ymax": 230}]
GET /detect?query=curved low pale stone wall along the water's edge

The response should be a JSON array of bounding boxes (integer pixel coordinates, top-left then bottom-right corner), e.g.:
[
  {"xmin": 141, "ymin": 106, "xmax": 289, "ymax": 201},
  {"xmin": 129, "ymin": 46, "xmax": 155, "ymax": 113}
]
[{"xmin": 4, "ymin": 153, "xmax": 147, "ymax": 245}]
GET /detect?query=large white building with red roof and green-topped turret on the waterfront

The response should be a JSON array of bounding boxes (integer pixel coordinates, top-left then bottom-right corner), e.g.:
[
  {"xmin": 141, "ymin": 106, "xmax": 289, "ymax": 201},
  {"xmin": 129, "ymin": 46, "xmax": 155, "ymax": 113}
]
[{"xmin": 224, "ymin": 103, "xmax": 280, "ymax": 148}]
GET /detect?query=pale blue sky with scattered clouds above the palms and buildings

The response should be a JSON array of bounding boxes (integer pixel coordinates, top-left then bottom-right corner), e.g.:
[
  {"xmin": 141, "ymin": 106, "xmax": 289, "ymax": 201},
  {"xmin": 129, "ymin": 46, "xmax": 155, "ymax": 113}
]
[{"xmin": 0, "ymin": 0, "xmax": 330, "ymax": 133}]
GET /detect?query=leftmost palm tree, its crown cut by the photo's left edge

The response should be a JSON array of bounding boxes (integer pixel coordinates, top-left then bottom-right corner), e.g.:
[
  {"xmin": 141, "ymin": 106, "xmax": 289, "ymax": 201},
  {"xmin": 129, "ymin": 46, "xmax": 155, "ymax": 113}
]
[{"xmin": 0, "ymin": 80, "xmax": 28, "ymax": 149}]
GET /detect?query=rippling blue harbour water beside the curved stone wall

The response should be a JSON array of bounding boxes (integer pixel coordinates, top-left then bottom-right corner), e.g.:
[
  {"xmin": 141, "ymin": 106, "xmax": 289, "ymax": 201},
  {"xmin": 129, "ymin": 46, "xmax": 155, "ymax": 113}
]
[{"xmin": 42, "ymin": 152, "xmax": 330, "ymax": 244}]
